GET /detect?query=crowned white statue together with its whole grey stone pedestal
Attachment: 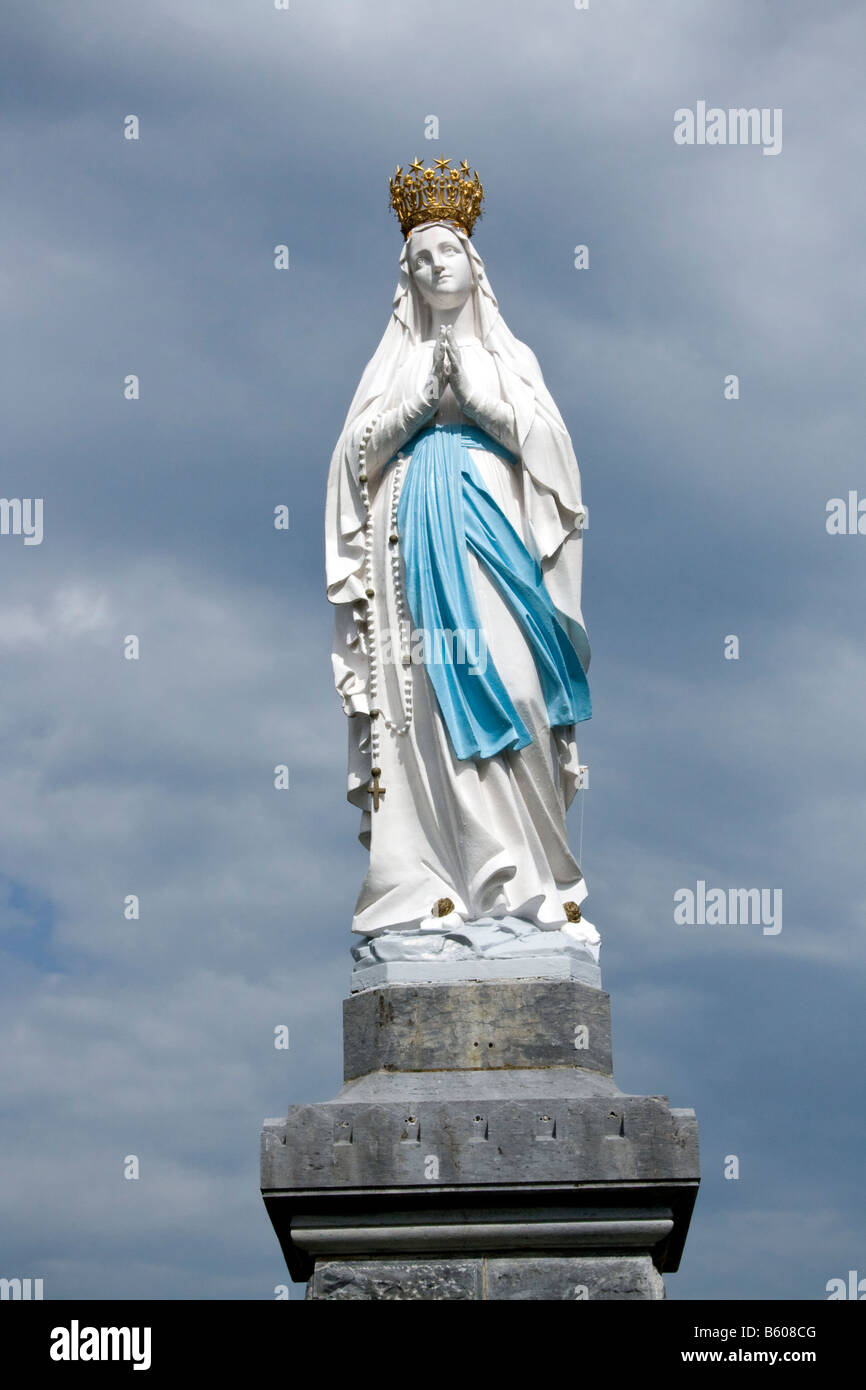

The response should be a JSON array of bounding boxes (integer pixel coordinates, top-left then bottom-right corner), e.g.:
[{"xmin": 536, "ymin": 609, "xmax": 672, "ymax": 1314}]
[{"xmin": 268, "ymin": 202, "xmax": 699, "ymax": 1301}]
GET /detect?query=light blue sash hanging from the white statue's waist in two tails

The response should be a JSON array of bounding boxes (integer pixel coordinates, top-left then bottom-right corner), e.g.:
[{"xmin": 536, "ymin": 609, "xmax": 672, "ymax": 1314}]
[{"xmin": 398, "ymin": 424, "xmax": 592, "ymax": 759}]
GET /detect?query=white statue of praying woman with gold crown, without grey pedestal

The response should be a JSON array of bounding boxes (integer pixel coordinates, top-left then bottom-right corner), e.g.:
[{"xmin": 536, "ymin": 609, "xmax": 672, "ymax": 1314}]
[{"xmin": 325, "ymin": 160, "xmax": 599, "ymax": 960}]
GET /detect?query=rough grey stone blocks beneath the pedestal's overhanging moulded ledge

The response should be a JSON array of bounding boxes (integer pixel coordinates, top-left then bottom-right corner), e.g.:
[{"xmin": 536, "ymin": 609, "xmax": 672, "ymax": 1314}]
[{"xmin": 307, "ymin": 1255, "xmax": 664, "ymax": 1302}]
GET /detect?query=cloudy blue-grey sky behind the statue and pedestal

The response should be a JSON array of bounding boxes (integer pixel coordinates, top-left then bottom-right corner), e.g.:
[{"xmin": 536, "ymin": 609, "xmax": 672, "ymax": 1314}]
[{"xmin": 0, "ymin": 0, "xmax": 866, "ymax": 1300}]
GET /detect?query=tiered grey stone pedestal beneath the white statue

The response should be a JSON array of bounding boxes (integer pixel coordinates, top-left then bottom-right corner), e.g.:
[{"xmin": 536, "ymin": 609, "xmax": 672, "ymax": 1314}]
[{"xmin": 261, "ymin": 979, "xmax": 699, "ymax": 1300}]
